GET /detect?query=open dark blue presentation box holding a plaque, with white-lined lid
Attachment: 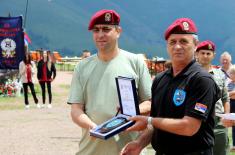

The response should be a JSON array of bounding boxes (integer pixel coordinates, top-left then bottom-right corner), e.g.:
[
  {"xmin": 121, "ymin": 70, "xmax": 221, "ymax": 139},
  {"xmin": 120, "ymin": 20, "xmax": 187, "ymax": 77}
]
[{"xmin": 90, "ymin": 76, "xmax": 140, "ymax": 139}]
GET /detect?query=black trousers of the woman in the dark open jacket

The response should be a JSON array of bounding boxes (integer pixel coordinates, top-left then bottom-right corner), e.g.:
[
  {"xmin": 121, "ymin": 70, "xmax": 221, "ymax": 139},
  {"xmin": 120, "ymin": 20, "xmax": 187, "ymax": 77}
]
[{"xmin": 39, "ymin": 81, "xmax": 52, "ymax": 104}]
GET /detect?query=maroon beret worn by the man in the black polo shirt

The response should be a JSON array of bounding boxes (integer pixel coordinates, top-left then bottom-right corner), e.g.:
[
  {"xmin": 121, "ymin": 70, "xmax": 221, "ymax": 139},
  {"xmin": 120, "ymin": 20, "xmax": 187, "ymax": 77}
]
[{"xmin": 165, "ymin": 18, "xmax": 197, "ymax": 40}]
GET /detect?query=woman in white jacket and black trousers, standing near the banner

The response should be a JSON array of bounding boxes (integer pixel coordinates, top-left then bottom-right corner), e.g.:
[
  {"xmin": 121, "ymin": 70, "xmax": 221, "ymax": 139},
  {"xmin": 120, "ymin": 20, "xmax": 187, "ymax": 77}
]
[{"xmin": 19, "ymin": 52, "xmax": 40, "ymax": 109}]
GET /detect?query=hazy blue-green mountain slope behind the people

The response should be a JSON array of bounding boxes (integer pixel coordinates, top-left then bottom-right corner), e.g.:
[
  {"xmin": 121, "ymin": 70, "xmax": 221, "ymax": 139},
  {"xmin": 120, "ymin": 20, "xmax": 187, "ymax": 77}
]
[{"xmin": 0, "ymin": 0, "xmax": 235, "ymax": 61}]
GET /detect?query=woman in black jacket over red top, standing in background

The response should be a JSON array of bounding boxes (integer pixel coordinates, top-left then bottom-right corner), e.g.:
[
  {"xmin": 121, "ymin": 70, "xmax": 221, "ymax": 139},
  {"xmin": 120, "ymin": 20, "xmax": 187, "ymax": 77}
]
[{"xmin": 37, "ymin": 51, "xmax": 56, "ymax": 108}]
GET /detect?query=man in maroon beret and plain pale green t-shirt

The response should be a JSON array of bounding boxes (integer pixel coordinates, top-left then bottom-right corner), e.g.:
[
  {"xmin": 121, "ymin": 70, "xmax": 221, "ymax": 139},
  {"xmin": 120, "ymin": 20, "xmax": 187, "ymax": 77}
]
[{"xmin": 68, "ymin": 10, "xmax": 152, "ymax": 155}]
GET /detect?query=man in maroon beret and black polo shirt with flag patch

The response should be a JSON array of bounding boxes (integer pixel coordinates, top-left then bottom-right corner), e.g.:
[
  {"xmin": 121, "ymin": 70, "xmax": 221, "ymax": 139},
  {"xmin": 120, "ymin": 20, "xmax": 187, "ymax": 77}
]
[{"xmin": 121, "ymin": 18, "xmax": 219, "ymax": 155}]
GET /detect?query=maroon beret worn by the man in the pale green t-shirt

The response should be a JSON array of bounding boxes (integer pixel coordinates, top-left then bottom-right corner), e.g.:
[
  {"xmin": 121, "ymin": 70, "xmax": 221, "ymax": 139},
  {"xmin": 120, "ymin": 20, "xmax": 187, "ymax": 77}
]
[{"xmin": 88, "ymin": 10, "xmax": 120, "ymax": 30}]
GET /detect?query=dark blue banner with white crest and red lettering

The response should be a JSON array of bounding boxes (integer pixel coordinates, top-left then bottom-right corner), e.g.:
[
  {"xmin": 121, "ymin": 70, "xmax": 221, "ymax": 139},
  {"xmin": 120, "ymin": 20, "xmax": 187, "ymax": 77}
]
[{"xmin": 0, "ymin": 16, "xmax": 25, "ymax": 69}]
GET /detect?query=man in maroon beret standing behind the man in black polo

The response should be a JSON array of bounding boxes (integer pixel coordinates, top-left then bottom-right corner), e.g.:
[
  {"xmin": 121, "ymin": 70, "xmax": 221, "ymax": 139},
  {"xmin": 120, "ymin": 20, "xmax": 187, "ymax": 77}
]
[{"xmin": 196, "ymin": 40, "xmax": 230, "ymax": 155}]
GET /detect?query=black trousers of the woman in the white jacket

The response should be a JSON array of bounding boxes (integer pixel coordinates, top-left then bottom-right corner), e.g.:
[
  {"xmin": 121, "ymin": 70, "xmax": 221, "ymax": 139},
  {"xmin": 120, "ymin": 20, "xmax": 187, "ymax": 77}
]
[{"xmin": 23, "ymin": 82, "xmax": 38, "ymax": 105}]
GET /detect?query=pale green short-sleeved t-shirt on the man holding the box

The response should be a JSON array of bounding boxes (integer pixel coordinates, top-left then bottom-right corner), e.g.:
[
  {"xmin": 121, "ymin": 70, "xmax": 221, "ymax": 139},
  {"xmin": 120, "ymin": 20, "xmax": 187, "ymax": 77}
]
[{"xmin": 68, "ymin": 49, "xmax": 152, "ymax": 155}]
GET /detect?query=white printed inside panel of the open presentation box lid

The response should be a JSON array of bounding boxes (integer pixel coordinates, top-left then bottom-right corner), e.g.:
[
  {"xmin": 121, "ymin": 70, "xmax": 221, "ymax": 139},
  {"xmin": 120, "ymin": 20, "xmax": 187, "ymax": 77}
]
[{"xmin": 118, "ymin": 79, "xmax": 137, "ymax": 116}]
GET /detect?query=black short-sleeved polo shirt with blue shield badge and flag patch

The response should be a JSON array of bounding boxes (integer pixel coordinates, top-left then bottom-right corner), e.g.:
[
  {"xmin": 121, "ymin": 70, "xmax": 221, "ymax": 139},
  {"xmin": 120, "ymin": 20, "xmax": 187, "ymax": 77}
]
[{"xmin": 151, "ymin": 60, "xmax": 220, "ymax": 154}]
